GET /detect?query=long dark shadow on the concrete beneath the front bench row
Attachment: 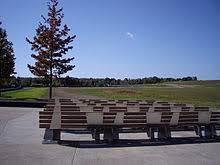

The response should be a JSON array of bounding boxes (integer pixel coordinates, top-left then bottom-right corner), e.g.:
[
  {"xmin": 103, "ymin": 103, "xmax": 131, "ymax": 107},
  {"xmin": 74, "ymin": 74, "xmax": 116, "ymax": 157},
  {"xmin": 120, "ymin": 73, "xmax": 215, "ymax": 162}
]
[{"xmin": 58, "ymin": 136, "xmax": 220, "ymax": 148}]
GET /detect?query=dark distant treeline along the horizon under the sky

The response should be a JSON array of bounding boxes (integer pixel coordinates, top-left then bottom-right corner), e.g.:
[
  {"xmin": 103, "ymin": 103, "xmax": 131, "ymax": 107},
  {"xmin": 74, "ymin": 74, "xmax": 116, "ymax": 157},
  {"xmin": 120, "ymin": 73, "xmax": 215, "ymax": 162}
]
[{"xmin": 7, "ymin": 76, "xmax": 197, "ymax": 87}]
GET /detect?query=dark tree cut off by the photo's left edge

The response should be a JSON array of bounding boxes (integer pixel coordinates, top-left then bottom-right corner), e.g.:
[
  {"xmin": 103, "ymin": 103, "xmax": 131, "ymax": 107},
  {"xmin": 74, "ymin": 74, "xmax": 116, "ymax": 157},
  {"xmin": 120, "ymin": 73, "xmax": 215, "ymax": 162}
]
[{"xmin": 0, "ymin": 22, "xmax": 15, "ymax": 96}]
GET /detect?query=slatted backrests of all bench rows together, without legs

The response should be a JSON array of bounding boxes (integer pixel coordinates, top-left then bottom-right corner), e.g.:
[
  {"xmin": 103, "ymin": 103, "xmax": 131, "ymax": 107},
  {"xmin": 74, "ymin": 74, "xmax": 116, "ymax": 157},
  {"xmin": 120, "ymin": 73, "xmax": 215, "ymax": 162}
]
[{"xmin": 39, "ymin": 99, "xmax": 220, "ymax": 129}]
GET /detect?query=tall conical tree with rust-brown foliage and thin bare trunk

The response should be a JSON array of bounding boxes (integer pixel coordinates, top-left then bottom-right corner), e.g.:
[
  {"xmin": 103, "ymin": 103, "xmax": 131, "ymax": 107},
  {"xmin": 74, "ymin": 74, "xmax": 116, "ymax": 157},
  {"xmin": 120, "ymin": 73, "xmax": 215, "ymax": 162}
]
[{"xmin": 26, "ymin": 0, "xmax": 76, "ymax": 98}]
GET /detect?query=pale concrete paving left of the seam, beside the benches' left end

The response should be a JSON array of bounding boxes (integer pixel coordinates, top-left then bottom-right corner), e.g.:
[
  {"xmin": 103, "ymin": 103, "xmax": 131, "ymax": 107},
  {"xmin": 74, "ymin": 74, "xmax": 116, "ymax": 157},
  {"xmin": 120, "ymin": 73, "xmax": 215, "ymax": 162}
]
[{"xmin": 0, "ymin": 107, "xmax": 75, "ymax": 165}]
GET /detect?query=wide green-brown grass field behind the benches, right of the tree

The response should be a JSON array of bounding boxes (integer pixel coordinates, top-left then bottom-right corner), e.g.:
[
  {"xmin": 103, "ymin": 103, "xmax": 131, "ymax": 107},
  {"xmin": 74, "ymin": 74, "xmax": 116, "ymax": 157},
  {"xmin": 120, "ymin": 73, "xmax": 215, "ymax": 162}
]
[{"xmin": 66, "ymin": 80, "xmax": 220, "ymax": 107}]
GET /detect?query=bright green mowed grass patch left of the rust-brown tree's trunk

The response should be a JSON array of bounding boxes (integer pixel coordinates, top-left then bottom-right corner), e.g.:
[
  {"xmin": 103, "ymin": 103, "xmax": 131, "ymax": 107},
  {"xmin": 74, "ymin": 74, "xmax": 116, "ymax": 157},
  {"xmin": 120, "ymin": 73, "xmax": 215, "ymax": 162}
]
[{"xmin": 0, "ymin": 88, "xmax": 48, "ymax": 100}]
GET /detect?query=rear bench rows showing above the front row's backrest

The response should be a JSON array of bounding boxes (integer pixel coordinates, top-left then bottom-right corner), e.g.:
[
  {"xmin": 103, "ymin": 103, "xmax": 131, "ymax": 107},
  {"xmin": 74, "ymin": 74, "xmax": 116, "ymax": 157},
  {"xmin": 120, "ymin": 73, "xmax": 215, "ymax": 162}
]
[{"xmin": 46, "ymin": 99, "xmax": 216, "ymax": 112}]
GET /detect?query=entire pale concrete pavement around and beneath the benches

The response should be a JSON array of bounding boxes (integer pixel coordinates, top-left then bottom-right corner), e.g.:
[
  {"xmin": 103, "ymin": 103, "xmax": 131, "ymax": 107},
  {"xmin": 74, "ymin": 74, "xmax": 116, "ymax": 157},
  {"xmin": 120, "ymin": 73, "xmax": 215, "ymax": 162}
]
[{"xmin": 0, "ymin": 107, "xmax": 220, "ymax": 165}]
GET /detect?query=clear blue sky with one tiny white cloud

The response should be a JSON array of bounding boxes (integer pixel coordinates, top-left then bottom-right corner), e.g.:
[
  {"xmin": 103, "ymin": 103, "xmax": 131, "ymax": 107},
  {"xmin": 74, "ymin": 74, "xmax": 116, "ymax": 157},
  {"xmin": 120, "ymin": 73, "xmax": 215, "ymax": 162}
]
[{"xmin": 0, "ymin": 0, "xmax": 220, "ymax": 79}]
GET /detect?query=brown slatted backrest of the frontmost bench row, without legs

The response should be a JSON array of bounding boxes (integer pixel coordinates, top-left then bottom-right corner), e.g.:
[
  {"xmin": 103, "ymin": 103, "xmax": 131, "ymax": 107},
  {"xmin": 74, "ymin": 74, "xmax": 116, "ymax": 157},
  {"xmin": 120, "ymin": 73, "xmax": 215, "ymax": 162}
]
[{"xmin": 39, "ymin": 110, "xmax": 220, "ymax": 129}]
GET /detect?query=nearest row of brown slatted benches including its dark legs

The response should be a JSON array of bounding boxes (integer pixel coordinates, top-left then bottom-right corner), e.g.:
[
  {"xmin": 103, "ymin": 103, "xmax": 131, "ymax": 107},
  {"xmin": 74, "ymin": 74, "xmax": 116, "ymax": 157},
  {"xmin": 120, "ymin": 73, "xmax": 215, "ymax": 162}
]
[{"xmin": 39, "ymin": 99, "xmax": 220, "ymax": 141}]
